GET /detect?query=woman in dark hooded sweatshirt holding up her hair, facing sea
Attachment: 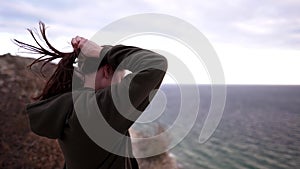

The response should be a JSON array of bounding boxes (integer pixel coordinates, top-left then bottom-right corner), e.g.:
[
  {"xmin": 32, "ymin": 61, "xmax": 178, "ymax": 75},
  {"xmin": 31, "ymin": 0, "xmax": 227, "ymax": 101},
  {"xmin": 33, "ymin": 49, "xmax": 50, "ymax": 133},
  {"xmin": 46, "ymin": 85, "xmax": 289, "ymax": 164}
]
[{"xmin": 15, "ymin": 22, "xmax": 167, "ymax": 169}]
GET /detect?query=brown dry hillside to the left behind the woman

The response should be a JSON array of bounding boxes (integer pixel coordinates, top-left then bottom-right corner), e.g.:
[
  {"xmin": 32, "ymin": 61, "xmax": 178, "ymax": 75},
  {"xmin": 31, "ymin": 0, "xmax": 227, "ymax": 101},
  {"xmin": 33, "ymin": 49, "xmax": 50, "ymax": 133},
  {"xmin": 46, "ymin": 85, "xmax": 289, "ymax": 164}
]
[{"xmin": 0, "ymin": 54, "xmax": 63, "ymax": 169}]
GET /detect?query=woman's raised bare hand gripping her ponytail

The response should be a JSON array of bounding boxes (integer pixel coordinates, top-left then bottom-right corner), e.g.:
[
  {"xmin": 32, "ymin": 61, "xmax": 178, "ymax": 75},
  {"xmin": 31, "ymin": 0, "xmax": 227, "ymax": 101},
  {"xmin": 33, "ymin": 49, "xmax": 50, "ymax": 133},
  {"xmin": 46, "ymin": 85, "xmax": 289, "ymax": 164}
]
[{"xmin": 71, "ymin": 36, "xmax": 102, "ymax": 57}]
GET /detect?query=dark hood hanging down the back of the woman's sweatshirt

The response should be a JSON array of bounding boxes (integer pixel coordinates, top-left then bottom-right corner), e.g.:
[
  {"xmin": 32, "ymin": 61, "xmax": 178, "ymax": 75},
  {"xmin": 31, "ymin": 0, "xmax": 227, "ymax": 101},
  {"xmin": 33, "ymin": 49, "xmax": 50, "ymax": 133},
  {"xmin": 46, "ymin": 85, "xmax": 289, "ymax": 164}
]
[{"xmin": 26, "ymin": 92, "xmax": 73, "ymax": 139}]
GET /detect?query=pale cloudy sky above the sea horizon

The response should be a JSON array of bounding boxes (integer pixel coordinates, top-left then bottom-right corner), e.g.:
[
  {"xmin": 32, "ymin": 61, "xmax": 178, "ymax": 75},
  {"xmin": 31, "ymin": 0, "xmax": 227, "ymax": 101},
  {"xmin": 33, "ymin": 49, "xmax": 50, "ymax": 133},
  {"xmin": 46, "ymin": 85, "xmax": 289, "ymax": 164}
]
[{"xmin": 0, "ymin": 0, "xmax": 300, "ymax": 85}]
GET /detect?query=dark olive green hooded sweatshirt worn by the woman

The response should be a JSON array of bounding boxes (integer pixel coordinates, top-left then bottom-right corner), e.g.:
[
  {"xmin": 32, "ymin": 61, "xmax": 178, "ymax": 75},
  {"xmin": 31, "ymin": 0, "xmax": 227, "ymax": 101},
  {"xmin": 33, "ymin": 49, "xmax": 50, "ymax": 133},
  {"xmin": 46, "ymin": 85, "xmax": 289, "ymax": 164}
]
[{"xmin": 27, "ymin": 45, "xmax": 167, "ymax": 169}]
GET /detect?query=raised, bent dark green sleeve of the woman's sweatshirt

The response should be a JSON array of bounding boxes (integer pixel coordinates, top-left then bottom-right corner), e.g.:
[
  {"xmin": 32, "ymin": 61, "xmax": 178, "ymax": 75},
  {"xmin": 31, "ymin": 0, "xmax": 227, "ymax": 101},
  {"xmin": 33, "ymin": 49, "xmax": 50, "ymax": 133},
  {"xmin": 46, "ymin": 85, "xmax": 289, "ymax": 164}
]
[{"xmin": 96, "ymin": 45, "xmax": 167, "ymax": 133}]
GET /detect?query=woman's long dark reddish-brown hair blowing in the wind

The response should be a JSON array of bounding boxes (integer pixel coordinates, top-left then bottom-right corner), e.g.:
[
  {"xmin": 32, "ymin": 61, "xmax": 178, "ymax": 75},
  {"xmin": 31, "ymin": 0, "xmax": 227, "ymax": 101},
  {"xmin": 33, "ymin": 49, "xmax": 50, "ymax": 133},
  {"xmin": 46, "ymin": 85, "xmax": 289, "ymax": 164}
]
[{"xmin": 13, "ymin": 22, "xmax": 82, "ymax": 100}]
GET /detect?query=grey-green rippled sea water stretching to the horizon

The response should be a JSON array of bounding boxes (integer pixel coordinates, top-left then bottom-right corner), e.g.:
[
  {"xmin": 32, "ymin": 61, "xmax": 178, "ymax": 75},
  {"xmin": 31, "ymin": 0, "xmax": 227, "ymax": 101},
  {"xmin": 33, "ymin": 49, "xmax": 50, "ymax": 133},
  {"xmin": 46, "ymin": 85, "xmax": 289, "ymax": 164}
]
[{"xmin": 135, "ymin": 85, "xmax": 300, "ymax": 169}]
